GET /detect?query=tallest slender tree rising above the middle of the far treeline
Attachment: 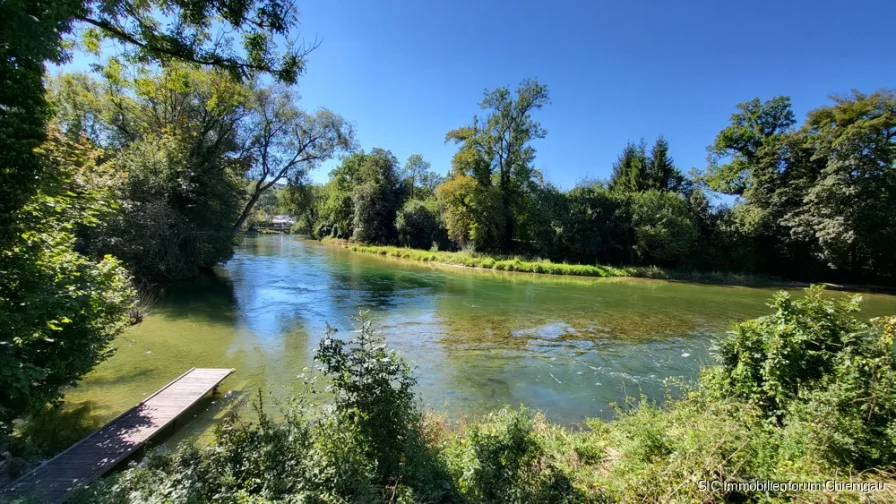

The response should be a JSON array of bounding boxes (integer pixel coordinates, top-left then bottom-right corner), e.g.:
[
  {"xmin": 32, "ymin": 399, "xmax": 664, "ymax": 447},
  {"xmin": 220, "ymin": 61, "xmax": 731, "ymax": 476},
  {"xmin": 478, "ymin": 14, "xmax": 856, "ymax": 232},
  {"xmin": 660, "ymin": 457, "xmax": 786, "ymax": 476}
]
[{"xmin": 445, "ymin": 80, "xmax": 549, "ymax": 252}]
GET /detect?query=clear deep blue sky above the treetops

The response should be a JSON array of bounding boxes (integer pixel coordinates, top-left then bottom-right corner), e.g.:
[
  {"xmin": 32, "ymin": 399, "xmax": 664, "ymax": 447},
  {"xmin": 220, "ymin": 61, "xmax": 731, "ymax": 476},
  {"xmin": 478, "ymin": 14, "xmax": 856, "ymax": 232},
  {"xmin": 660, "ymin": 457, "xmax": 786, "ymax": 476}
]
[{"xmin": 65, "ymin": 0, "xmax": 896, "ymax": 188}]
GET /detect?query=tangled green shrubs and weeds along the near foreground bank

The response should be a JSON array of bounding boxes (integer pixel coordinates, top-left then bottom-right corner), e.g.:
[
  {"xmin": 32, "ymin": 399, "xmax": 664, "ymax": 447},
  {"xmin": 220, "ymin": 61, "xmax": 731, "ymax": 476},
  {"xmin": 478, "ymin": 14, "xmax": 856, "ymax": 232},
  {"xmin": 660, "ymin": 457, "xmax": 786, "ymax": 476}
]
[{"xmin": 57, "ymin": 288, "xmax": 896, "ymax": 503}]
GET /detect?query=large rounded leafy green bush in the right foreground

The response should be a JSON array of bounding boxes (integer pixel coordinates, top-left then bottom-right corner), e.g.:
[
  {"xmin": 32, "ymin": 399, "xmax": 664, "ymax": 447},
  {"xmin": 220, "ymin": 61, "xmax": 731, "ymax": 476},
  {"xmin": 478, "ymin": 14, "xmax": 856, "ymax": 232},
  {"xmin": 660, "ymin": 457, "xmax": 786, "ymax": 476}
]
[{"xmin": 706, "ymin": 287, "xmax": 896, "ymax": 470}]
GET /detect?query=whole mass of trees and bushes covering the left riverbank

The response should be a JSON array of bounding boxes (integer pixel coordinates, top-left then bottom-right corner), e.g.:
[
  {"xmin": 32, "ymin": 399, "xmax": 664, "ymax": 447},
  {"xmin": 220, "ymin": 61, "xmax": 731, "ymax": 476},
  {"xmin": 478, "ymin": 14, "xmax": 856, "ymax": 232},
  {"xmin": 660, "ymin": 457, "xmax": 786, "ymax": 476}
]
[{"xmin": 0, "ymin": 0, "xmax": 328, "ymax": 453}]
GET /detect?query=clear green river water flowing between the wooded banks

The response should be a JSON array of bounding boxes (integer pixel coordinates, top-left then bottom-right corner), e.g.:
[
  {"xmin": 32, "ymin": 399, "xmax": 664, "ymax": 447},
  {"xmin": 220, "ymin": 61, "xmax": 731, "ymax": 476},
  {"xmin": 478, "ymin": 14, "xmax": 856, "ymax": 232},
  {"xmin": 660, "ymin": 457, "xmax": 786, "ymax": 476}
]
[{"xmin": 66, "ymin": 236, "xmax": 896, "ymax": 440}]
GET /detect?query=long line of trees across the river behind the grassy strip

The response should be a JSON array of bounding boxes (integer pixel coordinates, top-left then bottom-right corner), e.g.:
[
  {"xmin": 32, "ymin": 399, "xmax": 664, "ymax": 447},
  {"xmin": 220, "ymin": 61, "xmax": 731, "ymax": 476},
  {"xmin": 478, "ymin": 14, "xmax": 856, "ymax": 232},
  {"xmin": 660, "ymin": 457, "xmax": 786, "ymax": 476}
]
[{"xmin": 283, "ymin": 81, "xmax": 896, "ymax": 283}]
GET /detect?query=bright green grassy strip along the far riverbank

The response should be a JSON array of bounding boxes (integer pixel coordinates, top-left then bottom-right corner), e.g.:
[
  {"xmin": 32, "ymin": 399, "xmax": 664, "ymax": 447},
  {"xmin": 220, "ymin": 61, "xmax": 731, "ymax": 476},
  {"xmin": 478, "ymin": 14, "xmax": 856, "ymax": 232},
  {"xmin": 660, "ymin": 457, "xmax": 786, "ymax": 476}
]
[{"xmin": 346, "ymin": 245, "xmax": 788, "ymax": 286}]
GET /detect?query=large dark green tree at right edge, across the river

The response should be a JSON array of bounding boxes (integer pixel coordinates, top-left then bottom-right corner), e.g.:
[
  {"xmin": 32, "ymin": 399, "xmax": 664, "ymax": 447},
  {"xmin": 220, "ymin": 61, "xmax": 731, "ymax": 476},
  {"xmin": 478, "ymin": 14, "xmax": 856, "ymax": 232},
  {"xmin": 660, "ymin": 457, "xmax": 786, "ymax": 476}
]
[{"xmin": 785, "ymin": 91, "xmax": 896, "ymax": 279}]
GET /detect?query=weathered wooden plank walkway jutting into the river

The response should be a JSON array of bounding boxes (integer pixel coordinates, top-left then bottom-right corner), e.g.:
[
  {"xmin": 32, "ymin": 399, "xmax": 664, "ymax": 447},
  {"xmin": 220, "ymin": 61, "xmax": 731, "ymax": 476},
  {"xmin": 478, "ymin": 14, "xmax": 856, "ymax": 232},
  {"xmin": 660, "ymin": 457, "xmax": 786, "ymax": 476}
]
[{"xmin": 0, "ymin": 368, "xmax": 234, "ymax": 503}]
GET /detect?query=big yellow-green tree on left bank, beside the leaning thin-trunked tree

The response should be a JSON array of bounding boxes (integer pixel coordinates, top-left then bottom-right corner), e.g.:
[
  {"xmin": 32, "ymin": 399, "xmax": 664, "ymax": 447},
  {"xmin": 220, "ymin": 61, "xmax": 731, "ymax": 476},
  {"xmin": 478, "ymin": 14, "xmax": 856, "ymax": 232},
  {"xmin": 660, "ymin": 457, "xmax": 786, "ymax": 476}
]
[{"xmin": 51, "ymin": 64, "xmax": 251, "ymax": 281}]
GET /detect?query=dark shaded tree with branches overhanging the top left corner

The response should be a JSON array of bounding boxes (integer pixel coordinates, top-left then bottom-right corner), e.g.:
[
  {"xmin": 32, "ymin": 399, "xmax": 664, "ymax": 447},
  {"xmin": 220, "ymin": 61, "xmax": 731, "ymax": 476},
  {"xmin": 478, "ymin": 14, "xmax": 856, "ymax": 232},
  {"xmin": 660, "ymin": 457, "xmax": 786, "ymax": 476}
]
[{"xmin": 0, "ymin": 0, "xmax": 313, "ymax": 243}]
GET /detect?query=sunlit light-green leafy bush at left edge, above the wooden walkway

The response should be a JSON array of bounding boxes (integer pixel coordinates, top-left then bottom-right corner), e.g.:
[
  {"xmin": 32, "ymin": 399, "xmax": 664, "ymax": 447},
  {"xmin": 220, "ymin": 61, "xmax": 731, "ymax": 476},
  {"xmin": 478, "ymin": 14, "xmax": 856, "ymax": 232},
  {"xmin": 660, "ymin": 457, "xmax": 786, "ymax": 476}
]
[{"xmin": 0, "ymin": 130, "xmax": 136, "ymax": 438}]
